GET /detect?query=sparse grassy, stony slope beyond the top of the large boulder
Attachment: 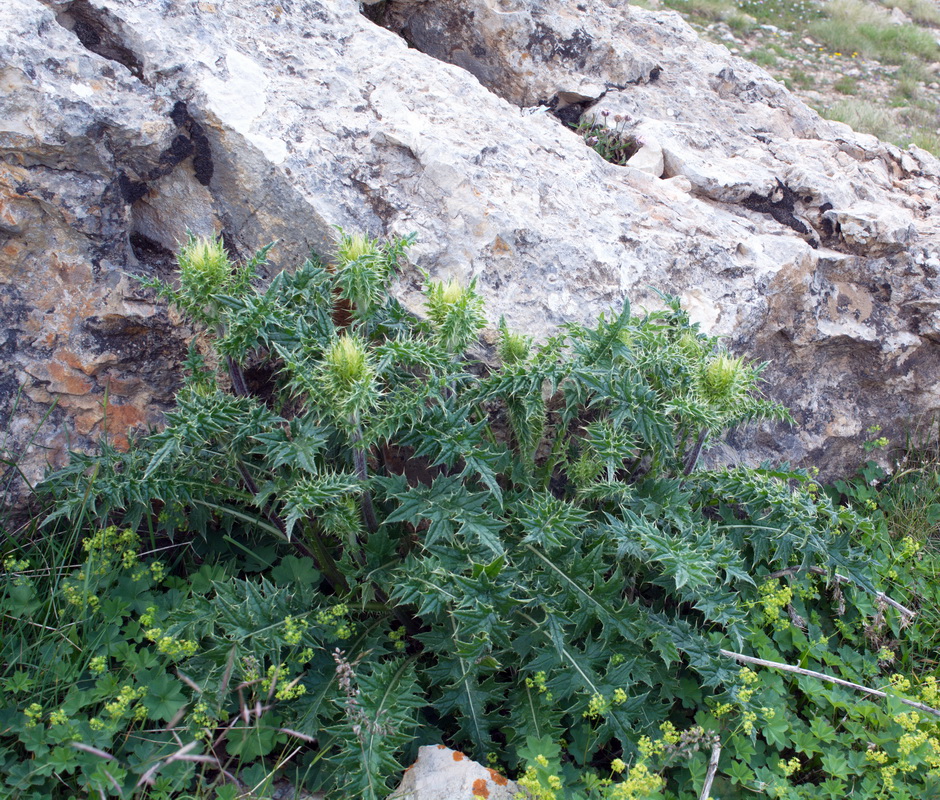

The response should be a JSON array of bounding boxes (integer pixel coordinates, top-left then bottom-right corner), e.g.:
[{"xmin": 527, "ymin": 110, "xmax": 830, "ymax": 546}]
[{"xmin": 666, "ymin": 0, "xmax": 940, "ymax": 155}]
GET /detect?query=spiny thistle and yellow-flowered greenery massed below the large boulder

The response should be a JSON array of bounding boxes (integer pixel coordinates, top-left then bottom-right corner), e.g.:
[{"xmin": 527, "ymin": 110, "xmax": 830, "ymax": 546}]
[{"xmin": 0, "ymin": 234, "xmax": 940, "ymax": 800}]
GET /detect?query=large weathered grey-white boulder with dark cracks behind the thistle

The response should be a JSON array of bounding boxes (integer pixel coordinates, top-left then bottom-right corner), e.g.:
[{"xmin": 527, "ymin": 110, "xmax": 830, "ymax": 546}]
[{"xmin": 0, "ymin": 0, "xmax": 940, "ymax": 494}]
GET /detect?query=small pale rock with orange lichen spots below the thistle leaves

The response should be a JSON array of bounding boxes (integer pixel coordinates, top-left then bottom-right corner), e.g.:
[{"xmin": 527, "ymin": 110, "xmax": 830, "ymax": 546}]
[{"xmin": 388, "ymin": 744, "xmax": 527, "ymax": 800}]
